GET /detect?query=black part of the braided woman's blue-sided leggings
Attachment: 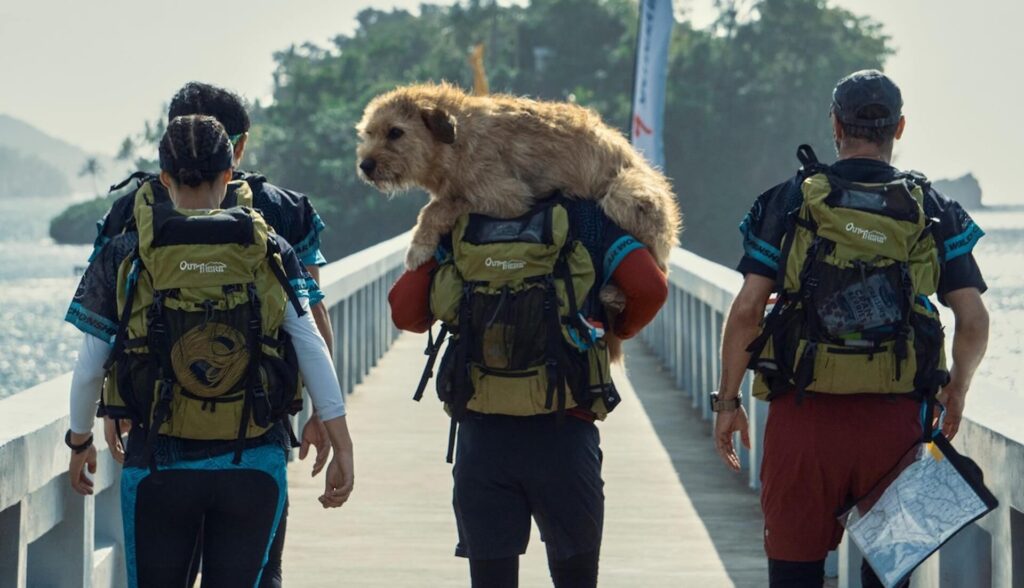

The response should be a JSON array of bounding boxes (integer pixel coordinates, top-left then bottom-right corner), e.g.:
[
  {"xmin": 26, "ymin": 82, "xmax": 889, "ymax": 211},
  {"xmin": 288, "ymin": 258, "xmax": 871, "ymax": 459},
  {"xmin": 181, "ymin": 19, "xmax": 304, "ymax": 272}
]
[{"xmin": 128, "ymin": 469, "xmax": 279, "ymax": 588}]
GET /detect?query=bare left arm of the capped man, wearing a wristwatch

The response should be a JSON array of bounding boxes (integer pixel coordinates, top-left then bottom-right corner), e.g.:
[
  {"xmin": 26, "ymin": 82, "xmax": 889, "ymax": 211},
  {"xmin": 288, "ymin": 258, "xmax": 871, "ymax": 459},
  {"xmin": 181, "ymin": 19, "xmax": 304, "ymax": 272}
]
[{"xmin": 715, "ymin": 274, "xmax": 775, "ymax": 471}]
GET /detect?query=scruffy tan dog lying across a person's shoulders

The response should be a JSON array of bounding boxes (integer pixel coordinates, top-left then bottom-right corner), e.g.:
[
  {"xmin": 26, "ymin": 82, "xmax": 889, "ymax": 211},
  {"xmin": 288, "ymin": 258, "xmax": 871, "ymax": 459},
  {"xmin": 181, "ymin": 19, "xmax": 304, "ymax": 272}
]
[{"xmin": 356, "ymin": 84, "xmax": 681, "ymax": 274}]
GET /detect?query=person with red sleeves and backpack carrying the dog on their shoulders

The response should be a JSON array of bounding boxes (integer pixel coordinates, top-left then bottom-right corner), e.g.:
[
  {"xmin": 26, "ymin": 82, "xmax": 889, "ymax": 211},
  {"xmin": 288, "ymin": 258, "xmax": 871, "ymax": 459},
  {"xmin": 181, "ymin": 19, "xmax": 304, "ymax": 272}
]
[{"xmin": 388, "ymin": 195, "xmax": 668, "ymax": 588}]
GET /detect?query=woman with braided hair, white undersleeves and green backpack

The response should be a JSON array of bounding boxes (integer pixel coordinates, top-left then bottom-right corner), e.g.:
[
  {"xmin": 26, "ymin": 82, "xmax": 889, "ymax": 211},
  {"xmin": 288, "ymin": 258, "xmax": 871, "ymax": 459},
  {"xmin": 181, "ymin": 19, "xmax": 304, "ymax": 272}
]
[{"xmin": 66, "ymin": 116, "xmax": 353, "ymax": 588}]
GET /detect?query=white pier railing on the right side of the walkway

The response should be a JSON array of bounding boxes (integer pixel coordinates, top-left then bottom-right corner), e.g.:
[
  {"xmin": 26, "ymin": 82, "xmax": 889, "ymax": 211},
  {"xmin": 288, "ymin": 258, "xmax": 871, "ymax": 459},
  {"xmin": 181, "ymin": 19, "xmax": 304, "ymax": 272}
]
[{"xmin": 641, "ymin": 249, "xmax": 1024, "ymax": 588}]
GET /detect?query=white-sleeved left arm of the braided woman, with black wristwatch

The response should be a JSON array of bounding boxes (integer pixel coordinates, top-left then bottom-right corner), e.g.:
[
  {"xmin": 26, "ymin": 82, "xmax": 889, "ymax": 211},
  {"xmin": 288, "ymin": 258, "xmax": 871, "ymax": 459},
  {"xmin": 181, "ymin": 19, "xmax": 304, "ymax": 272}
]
[{"xmin": 68, "ymin": 335, "xmax": 111, "ymax": 496}]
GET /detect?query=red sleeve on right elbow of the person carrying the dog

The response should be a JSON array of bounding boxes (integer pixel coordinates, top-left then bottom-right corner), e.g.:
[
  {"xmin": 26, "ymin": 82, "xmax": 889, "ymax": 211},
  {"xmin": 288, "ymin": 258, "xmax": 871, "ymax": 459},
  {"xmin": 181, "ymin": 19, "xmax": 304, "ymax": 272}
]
[{"xmin": 611, "ymin": 249, "xmax": 669, "ymax": 339}]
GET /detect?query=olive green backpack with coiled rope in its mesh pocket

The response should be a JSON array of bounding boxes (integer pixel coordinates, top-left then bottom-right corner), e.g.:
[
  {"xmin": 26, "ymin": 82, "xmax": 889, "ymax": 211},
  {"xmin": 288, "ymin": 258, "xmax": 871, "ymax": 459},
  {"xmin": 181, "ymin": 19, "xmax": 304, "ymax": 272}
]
[{"xmin": 99, "ymin": 182, "xmax": 302, "ymax": 465}]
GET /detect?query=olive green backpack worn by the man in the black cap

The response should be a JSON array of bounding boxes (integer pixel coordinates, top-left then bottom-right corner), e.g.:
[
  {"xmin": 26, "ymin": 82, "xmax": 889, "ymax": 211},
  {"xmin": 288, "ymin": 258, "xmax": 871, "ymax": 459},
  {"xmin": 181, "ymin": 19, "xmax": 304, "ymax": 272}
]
[{"xmin": 748, "ymin": 145, "xmax": 948, "ymax": 400}]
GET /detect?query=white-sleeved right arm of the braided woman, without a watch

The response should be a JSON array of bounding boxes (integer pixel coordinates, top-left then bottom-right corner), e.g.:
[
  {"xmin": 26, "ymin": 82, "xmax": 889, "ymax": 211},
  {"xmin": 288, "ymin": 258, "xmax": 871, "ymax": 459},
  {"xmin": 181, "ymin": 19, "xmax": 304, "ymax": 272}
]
[{"xmin": 284, "ymin": 299, "xmax": 354, "ymax": 508}]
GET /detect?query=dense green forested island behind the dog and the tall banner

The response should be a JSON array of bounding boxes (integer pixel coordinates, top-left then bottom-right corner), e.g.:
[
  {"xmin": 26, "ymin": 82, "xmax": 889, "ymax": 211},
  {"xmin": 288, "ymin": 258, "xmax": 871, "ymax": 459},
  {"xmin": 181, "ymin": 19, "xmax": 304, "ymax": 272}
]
[{"xmin": 51, "ymin": 0, "xmax": 890, "ymax": 264}]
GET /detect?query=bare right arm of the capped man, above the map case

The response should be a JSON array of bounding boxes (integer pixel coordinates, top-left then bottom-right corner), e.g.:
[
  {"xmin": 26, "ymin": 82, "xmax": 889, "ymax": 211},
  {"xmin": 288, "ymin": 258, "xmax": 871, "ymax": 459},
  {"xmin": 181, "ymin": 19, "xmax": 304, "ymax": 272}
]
[{"xmin": 938, "ymin": 288, "xmax": 988, "ymax": 439}]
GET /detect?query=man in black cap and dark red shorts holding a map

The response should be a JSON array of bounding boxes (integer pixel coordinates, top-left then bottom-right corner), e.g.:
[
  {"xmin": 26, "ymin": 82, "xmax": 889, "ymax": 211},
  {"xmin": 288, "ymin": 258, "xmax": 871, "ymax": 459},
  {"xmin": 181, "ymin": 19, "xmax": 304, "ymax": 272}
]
[{"xmin": 713, "ymin": 70, "xmax": 988, "ymax": 587}]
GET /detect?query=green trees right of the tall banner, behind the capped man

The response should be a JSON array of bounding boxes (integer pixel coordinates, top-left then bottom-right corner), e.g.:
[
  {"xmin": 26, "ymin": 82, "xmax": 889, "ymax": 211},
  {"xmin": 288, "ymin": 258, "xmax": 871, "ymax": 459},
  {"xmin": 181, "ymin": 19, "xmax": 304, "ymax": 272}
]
[{"xmin": 665, "ymin": 0, "xmax": 891, "ymax": 265}]
